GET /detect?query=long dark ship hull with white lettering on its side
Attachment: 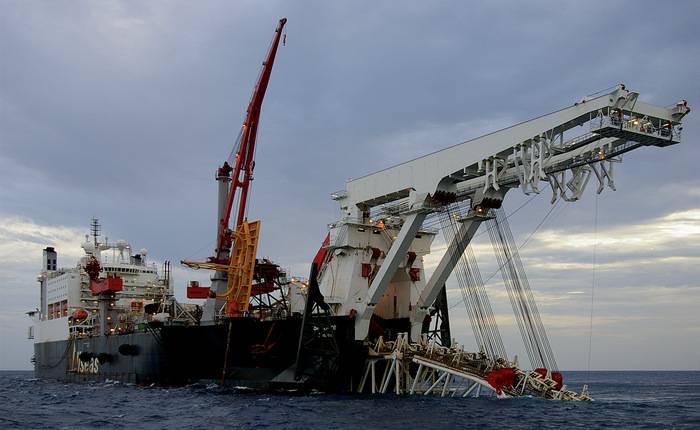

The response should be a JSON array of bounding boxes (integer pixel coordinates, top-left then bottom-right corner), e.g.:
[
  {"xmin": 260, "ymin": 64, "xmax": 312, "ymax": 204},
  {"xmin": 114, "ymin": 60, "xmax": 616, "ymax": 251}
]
[{"xmin": 34, "ymin": 317, "xmax": 366, "ymax": 392}]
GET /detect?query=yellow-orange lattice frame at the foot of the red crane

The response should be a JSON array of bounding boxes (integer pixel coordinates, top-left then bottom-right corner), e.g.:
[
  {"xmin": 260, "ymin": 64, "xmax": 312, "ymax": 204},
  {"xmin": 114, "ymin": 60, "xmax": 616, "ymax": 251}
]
[{"xmin": 182, "ymin": 220, "xmax": 260, "ymax": 316}]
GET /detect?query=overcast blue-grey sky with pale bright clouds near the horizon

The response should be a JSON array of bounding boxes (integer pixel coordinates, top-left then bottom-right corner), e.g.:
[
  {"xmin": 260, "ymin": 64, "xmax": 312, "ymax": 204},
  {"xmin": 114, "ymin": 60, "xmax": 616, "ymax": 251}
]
[{"xmin": 0, "ymin": 0, "xmax": 700, "ymax": 370}]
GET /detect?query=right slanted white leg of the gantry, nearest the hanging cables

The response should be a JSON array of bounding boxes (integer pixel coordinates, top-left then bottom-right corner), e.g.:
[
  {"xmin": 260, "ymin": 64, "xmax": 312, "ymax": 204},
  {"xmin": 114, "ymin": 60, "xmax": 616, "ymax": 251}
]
[{"xmin": 411, "ymin": 215, "xmax": 486, "ymax": 340}]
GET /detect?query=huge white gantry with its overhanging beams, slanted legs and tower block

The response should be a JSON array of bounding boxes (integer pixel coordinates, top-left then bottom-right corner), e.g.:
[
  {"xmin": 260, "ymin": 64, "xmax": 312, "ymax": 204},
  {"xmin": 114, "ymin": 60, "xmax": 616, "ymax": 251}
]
[{"xmin": 318, "ymin": 85, "xmax": 690, "ymax": 342}]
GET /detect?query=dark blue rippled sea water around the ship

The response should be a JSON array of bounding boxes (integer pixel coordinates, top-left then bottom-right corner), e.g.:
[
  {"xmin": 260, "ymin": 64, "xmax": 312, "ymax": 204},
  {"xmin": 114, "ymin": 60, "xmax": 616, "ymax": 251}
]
[{"xmin": 0, "ymin": 372, "xmax": 700, "ymax": 430}]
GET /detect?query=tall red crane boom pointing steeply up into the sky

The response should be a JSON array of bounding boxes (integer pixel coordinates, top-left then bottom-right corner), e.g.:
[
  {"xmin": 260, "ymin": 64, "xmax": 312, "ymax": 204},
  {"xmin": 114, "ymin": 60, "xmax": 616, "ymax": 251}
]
[{"xmin": 214, "ymin": 18, "xmax": 287, "ymax": 260}]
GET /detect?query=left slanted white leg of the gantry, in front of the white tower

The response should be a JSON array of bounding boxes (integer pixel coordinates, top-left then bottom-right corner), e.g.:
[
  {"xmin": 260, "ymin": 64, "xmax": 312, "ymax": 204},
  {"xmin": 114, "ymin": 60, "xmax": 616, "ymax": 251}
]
[{"xmin": 355, "ymin": 211, "xmax": 427, "ymax": 340}]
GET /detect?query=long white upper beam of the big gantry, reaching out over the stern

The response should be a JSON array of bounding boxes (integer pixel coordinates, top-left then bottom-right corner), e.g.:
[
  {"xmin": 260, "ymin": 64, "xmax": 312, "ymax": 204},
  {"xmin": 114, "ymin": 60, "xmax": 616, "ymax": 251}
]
[{"xmin": 333, "ymin": 84, "xmax": 688, "ymax": 213}]
